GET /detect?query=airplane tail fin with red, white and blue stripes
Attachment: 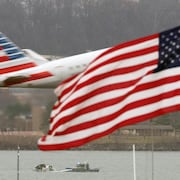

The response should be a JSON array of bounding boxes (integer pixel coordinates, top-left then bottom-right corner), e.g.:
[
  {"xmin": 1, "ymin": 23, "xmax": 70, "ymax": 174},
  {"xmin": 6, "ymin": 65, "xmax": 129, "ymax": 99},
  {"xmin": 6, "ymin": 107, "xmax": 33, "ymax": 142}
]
[{"xmin": 0, "ymin": 32, "xmax": 48, "ymax": 75}]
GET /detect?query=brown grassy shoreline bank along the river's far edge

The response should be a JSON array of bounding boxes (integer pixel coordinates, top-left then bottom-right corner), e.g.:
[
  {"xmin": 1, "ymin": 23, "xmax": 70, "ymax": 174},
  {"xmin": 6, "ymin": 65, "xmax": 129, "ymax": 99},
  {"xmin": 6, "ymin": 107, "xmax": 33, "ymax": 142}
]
[{"xmin": 0, "ymin": 133, "xmax": 180, "ymax": 151}]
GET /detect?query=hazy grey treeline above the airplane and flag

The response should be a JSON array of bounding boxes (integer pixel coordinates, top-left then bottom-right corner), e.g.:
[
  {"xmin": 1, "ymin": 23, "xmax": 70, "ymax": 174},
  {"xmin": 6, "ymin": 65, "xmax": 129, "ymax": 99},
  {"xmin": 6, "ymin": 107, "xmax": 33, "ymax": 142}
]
[{"xmin": 0, "ymin": 0, "xmax": 180, "ymax": 56}]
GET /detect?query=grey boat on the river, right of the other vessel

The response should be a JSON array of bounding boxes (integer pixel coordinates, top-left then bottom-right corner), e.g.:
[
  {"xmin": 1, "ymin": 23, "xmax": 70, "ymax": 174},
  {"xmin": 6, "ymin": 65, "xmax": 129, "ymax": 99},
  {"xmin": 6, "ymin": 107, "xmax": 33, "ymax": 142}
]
[{"xmin": 61, "ymin": 162, "xmax": 99, "ymax": 172}]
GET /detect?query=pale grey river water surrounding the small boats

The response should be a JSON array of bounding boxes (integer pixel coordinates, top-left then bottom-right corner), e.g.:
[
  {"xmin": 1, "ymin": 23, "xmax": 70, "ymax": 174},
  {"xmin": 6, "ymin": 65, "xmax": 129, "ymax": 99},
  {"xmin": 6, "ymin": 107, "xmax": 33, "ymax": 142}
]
[{"xmin": 0, "ymin": 151, "xmax": 180, "ymax": 180}]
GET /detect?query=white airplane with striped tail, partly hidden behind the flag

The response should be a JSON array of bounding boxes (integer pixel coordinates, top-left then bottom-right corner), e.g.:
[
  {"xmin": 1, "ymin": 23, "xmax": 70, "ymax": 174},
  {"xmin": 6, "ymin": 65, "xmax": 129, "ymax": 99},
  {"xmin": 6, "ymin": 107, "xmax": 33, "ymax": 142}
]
[{"xmin": 0, "ymin": 33, "xmax": 107, "ymax": 88}]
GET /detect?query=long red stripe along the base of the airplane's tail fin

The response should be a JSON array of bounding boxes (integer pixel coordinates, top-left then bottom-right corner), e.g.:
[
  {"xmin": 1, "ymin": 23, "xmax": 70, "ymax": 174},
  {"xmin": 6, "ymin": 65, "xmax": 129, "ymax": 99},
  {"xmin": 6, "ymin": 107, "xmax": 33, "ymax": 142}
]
[{"xmin": 0, "ymin": 62, "xmax": 36, "ymax": 74}]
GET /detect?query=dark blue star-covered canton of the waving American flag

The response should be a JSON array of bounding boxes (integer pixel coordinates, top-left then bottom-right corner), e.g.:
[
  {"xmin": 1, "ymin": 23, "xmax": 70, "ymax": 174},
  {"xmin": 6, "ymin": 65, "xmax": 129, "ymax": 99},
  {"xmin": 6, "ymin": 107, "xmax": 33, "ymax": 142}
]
[{"xmin": 154, "ymin": 26, "xmax": 180, "ymax": 72}]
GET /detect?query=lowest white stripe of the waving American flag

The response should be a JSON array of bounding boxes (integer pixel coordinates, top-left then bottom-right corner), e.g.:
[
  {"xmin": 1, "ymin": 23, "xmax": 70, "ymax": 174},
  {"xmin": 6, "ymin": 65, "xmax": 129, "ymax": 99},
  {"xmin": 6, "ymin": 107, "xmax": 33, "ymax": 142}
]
[{"xmin": 38, "ymin": 96, "xmax": 180, "ymax": 145}]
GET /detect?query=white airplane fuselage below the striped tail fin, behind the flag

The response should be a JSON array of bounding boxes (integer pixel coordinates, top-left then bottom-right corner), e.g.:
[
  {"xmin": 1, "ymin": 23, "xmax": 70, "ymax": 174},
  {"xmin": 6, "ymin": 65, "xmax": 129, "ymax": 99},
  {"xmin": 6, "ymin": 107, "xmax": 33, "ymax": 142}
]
[{"xmin": 0, "ymin": 49, "xmax": 107, "ymax": 88}]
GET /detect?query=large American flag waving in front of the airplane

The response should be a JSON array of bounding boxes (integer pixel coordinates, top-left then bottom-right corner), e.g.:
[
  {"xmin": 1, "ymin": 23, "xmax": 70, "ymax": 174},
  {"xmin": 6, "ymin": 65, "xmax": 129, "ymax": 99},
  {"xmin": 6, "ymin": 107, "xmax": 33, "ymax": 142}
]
[{"xmin": 38, "ymin": 26, "xmax": 180, "ymax": 150}]
